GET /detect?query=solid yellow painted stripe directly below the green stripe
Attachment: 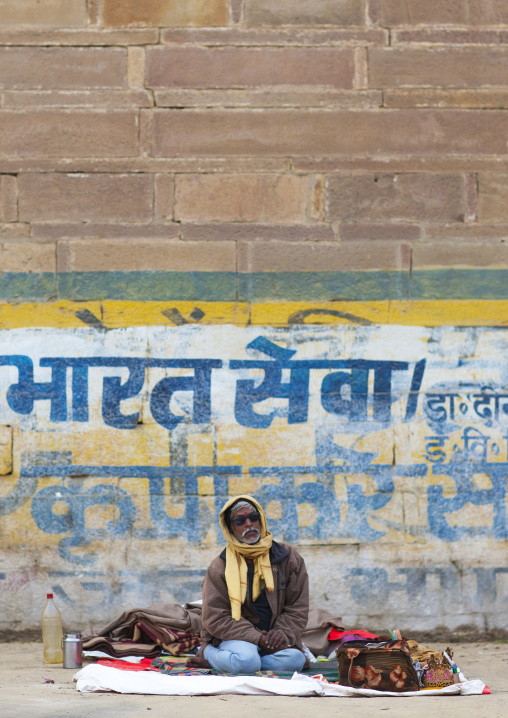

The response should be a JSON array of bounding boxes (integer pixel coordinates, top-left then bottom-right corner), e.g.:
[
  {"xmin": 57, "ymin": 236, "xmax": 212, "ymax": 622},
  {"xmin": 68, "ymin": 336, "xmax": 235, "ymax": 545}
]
[{"xmin": 0, "ymin": 300, "xmax": 508, "ymax": 329}]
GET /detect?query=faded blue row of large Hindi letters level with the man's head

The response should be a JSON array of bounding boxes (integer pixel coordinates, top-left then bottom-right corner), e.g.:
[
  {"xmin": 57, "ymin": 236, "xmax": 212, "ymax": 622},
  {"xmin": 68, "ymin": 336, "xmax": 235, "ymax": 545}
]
[{"xmin": 14, "ymin": 439, "xmax": 508, "ymax": 564}]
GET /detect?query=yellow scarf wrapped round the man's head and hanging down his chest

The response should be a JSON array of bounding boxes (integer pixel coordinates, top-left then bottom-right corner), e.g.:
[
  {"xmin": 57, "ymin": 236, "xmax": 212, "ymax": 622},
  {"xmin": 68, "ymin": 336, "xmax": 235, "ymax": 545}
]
[{"xmin": 219, "ymin": 495, "xmax": 273, "ymax": 621}]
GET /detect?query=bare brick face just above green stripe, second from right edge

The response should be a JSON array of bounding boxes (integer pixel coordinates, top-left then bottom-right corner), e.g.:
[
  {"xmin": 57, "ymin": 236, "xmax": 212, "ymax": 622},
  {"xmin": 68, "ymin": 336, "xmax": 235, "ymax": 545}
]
[{"xmin": 238, "ymin": 241, "xmax": 409, "ymax": 272}]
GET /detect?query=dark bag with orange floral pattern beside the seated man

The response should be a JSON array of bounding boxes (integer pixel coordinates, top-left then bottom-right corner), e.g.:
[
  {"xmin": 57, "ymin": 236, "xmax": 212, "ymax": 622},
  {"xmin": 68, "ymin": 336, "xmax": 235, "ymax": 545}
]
[{"xmin": 336, "ymin": 640, "xmax": 420, "ymax": 693}]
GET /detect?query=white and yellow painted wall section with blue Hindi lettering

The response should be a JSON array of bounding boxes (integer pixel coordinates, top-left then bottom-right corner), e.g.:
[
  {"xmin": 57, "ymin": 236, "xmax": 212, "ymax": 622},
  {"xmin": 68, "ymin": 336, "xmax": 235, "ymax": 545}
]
[{"xmin": 0, "ymin": 325, "xmax": 508, "ymax": 630}]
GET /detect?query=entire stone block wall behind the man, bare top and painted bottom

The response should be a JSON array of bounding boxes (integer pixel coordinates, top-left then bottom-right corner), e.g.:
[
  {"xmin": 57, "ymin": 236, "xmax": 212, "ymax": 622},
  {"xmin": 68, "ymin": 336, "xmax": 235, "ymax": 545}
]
[{"xmin": 0, "ymin": 0, "xmax": 508, "ymax": 630}]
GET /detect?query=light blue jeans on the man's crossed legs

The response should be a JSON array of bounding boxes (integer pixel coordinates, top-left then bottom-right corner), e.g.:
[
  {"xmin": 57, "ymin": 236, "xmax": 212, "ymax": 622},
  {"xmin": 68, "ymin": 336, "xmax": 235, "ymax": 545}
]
[{"xmin": 203, "ymin": 641, "xmax": 305, "ymax": 675}]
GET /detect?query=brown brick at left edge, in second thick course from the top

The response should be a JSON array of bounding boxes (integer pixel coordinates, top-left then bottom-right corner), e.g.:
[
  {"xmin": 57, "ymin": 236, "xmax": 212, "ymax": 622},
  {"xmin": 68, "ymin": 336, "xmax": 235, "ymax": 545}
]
[{"xmin": 0, "ymin": 47, "xmax": 127, "ymax": 90}]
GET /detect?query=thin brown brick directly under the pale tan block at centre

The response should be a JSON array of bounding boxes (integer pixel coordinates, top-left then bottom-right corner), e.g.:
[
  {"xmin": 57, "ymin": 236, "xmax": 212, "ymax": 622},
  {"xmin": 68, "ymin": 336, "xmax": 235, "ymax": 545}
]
[{"xmin": 182, "ymin": 222, "xmax": 335, "ymax": 242}]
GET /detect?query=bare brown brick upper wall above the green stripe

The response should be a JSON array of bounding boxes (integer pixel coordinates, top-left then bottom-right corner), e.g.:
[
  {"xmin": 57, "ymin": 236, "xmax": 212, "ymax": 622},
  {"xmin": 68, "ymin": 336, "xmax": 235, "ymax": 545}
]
[{"xmin": 0, "ymin": 0, "xmax": 508, "ymax": 300}]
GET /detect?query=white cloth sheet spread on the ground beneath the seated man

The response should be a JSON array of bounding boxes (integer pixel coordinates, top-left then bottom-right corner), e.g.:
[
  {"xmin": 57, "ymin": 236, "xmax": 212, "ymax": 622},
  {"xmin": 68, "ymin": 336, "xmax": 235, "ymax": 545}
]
[{"xmin": 74, "ymin": 663, "xmax": 485, "ymax": 698}]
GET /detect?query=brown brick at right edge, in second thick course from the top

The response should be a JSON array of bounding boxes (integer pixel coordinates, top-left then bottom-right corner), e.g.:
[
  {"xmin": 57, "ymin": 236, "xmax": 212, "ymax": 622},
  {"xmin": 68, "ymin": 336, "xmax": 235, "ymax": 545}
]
[{"xmin": 369, "ymin": 47, "xmax": 508, "ymax": 88}]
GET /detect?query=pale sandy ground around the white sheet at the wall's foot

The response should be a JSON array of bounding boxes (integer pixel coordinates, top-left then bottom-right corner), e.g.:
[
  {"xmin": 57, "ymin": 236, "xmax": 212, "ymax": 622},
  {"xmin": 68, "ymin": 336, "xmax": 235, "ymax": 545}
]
[{"xmin": 0, "ymin": 642, "xmax": 508, "ymax": 718}]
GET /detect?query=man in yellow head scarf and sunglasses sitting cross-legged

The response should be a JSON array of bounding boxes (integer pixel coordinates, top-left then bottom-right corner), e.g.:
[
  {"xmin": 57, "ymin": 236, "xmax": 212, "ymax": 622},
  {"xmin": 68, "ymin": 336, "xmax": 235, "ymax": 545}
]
[{"xmin": 187, "ymin": 496, "xmax": 309, "ymax": 674}]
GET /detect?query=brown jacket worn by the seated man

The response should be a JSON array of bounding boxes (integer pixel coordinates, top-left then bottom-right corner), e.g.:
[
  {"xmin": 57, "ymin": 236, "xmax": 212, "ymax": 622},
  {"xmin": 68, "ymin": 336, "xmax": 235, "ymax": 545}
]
[{"xmin": 199, "ymin": 541, "xmax": 309, "ymax": 653}]
